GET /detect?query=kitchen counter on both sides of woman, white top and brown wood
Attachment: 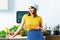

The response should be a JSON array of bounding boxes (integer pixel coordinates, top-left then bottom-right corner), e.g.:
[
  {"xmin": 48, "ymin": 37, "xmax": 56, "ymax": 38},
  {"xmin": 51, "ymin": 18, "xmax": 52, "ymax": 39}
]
[{"xmin": 0, "ymin": 35, "xmax": 60, "ymax": 40}]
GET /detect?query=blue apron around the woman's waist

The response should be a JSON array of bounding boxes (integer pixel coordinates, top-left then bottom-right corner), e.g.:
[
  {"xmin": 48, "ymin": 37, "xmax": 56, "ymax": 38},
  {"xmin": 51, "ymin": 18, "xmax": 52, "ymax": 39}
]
[{"xmin": 27, "ymin": 30, "xmax": 44, "ymax": 40}]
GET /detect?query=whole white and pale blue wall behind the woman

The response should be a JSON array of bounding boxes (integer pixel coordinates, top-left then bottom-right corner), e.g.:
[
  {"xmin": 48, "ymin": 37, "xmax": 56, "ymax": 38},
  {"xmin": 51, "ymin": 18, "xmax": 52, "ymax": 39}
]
[{"xmin": 0, "ymin": 0, "xmax": 60, "ymax": 30}]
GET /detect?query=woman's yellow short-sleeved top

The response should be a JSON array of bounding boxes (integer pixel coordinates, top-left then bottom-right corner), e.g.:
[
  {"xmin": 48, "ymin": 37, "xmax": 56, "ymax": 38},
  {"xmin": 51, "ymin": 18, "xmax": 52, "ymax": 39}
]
[{"xmin": 22, "ymin": 14, "xmax": 42, "ymax": 31}]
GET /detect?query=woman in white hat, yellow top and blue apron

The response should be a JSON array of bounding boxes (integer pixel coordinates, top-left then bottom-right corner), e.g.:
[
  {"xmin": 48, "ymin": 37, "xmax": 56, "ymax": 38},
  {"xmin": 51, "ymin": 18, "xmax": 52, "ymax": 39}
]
[{"xmin": 12, "ymin": 4, "xmax": 44, "ymax": 40}]
